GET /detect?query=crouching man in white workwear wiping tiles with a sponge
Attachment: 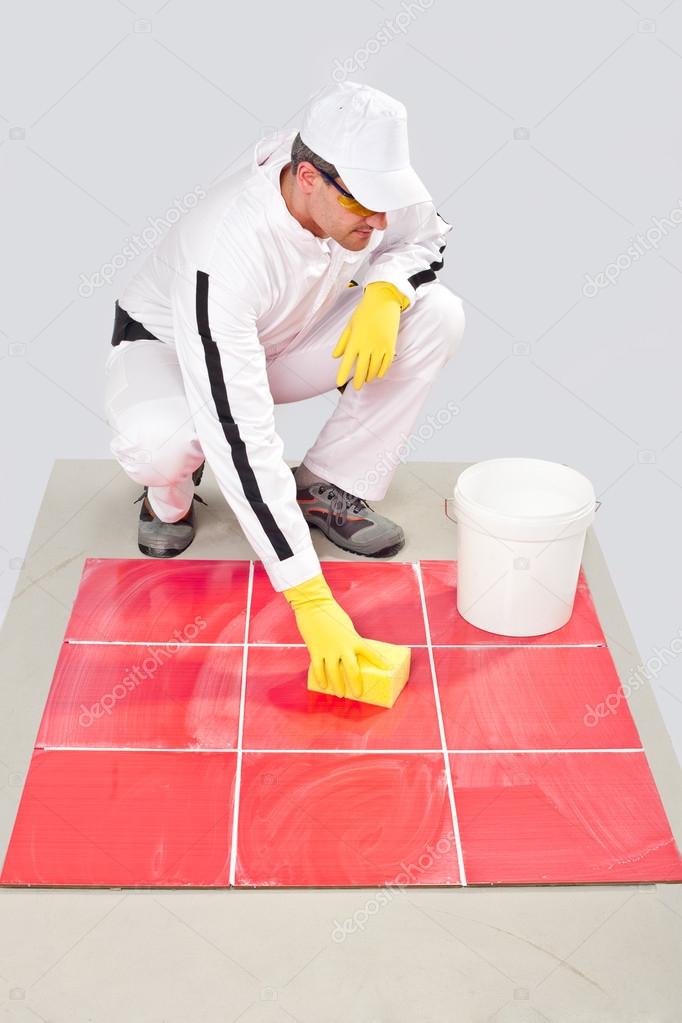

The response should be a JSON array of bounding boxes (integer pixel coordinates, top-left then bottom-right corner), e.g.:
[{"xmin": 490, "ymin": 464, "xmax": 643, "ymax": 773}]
[{"xmin": 106, "ymin": 82, "xmax": 464, "ymax": 695}]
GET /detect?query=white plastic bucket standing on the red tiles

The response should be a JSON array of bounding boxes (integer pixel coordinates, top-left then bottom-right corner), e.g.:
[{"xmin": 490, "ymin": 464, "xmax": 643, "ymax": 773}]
[{"xmin": 446, "ymin": 458, "xmax": 598, "ymax": 636}]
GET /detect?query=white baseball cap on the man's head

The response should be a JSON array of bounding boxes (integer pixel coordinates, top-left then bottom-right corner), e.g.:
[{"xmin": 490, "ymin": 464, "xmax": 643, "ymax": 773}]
[{"xmin": 300, "ymin": 82, "xmax": 431, "ymax": 213}]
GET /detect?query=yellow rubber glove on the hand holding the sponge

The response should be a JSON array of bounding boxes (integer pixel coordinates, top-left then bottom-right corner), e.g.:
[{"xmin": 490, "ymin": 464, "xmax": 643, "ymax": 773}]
[{"xmin": 282, "ymin": 574, "xmax": 391, "ymax": 699}]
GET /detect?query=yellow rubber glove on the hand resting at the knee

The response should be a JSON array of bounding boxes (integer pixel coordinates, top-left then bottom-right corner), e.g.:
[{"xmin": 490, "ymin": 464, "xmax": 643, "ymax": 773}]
[{"xmin": 331, "ymin": 280, "xmax": 410, "ymax": 391}]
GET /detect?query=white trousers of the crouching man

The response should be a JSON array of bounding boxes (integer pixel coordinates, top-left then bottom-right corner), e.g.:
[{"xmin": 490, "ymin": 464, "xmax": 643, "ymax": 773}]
[{"xmin": 104, "ymin": 281, "xmax": 465, "ymax": 522}]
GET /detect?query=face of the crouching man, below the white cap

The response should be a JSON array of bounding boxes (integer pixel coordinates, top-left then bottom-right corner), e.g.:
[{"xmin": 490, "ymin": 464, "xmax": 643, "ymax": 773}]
[{"xmin": 284, "ymin": 163, "xmax": 389, "ymax": 252}]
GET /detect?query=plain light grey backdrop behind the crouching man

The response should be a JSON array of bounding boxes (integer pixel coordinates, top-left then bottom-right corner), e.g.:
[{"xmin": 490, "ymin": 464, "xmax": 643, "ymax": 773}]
[{"xmin": 0, "ymin": 0, "xmax": 682, "ymax": 769}]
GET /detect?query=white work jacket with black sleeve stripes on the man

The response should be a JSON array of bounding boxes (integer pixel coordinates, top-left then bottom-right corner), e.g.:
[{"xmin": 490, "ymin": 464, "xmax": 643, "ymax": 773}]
[{"xmin": 118, "ymin": 131, "xmax": 452, "ymax": 590}]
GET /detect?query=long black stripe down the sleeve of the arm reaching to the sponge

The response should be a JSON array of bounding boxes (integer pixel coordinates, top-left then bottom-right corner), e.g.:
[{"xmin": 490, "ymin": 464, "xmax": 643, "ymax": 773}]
[{"xmin": 196, "ymin": 270, "xmax": 293, "ymax": 562}]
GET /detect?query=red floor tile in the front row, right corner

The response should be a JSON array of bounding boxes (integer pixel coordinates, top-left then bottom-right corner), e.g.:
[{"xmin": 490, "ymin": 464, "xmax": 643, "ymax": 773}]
[{"xmin": 451, "ymin": 753, "xmax": 682, "ymax": 884}]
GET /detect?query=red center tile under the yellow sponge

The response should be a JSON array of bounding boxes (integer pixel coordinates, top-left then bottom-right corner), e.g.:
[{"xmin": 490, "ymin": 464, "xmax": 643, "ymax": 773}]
[{"xmin": 243, "ymin": 647, "xmax": 441, "ymax": 750}]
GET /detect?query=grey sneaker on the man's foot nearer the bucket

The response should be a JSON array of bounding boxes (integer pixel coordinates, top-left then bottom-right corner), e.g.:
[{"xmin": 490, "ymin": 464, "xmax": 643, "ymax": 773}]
[{"xmin": 291, "ymin": 465, "xmax": 405, "ymax": 558}]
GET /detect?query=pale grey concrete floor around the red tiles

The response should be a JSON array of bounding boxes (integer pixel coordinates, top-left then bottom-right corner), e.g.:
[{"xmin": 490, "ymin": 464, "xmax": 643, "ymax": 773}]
[{"xmin": 0, "ymin": 460, "xmax": 682, "ymax": 1023}]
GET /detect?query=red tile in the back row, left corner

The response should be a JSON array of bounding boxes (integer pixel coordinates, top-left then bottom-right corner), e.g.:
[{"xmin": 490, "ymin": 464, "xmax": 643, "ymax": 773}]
[{"xmin": 65, "ymin": 558, "xmax": 248, "ymax": 643}]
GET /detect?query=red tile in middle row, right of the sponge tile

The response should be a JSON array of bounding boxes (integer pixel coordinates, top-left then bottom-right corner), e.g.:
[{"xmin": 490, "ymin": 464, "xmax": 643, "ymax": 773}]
[{"xmin": 434, "ymin": 647, "xmax": 641, "ymax": 750}]
